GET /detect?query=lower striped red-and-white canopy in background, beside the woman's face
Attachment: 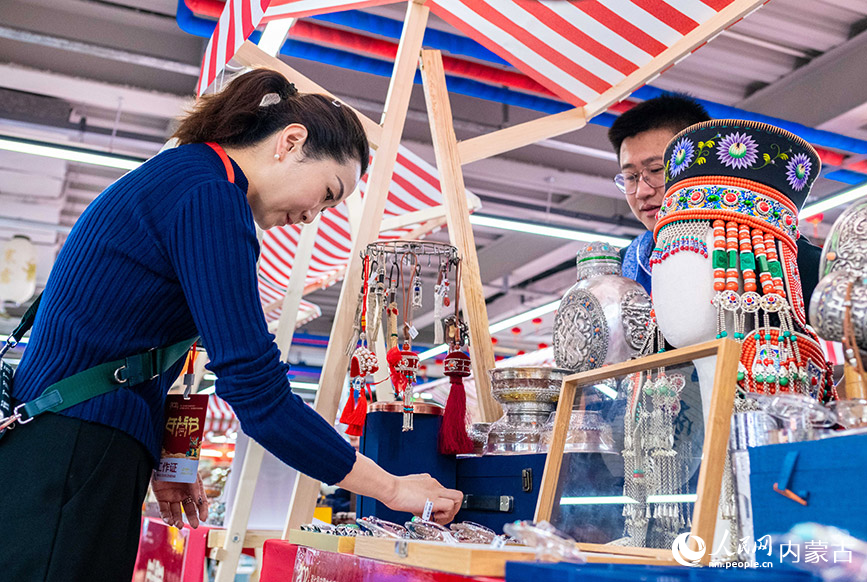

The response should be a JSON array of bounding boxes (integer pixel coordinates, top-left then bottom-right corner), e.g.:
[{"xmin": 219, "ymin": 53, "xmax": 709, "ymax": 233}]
[{"xmin": 259, "ymin": 146, "xmax": 468, "ymax": 319}]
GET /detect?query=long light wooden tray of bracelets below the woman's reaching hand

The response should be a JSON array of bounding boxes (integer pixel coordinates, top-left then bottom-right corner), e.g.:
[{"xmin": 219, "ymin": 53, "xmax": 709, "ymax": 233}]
[{"xmin": 355, "ymin": 537, "xmax": 536, "ymax": 578}]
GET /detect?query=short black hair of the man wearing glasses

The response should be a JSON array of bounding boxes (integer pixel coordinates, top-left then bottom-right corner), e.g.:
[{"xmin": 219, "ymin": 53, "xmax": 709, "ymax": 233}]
[{"xmin": 608, "ymin": 94, "xmax": 710, "ymax": 159}]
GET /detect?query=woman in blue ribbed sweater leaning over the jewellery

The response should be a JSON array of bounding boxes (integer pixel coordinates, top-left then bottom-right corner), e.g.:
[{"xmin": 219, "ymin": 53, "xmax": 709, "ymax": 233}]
[{"xmin": 0, "ymin": 70, "xmax": 461, "ymax": 582}]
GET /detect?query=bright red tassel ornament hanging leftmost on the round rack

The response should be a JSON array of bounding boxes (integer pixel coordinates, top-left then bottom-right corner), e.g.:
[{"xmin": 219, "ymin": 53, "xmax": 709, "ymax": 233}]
[{"xmin": 340, "ymin": 257, "xmax": 379, "ymax": 436}]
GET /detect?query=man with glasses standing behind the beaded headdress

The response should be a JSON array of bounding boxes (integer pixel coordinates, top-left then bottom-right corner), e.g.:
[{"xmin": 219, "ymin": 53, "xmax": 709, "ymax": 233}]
[{"xmin": 608, "ymin": 95, "xmax": 822, "ymax": 318}]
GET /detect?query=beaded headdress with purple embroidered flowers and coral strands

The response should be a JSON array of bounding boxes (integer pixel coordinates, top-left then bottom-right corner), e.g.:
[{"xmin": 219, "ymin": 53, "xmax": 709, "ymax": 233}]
[{"xmin": 651, "ymin": 119, "xmax": 831, "ymax": 399}]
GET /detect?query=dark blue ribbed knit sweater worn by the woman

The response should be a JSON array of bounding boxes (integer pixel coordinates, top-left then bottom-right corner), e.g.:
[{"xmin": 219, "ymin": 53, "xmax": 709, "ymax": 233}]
[{"xmin": 14, "ymin": 144, "xmax": 355, "ymax": 483}]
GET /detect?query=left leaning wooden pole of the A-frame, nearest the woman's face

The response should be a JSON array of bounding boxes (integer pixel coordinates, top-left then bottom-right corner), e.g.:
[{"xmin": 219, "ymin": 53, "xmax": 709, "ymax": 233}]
[{"xmin": 284, "ymin": 1, "xmax": 430, "ymax": 538}]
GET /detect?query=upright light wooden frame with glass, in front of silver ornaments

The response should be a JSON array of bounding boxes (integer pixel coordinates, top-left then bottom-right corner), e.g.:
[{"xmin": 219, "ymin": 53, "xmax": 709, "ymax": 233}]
[{"xmin": 534, "ymin": 339, "xmax": 741, "ymax": 564}]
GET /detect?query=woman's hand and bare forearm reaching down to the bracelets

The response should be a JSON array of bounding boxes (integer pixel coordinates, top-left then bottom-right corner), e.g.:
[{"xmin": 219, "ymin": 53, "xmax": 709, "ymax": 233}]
[{"xmin": 339, "ymin": 453, "xmax": 464, "ymax": 524}]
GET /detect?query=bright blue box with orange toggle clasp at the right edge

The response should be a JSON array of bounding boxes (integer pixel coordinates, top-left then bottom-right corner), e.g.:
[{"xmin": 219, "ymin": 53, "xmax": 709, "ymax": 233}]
[{"xmin": 749, "ymin": 434, "xmax": 867, "ymax": 540}]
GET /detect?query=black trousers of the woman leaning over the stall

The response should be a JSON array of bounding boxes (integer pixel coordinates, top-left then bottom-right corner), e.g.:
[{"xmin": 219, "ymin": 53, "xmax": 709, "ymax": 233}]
[{"xmin": 0, "ymin": 413, "xmax": 153, "ymax": 582}]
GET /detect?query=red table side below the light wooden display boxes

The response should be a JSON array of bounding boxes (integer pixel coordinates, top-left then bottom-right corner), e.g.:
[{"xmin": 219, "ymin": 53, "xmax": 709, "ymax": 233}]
[{"xmin": 260, "ymin": 540, "xmax": 503, "ymax": 582}]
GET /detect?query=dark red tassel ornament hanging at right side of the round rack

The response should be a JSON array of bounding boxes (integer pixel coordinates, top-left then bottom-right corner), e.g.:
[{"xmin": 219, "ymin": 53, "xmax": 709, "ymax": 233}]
[{"xmin": 438, "ymin": 263, "xmax": 473, "ymax": 455}]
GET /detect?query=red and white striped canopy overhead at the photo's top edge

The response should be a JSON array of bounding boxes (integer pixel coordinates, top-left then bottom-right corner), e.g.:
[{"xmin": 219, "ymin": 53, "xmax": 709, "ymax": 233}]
[{"xmin": 199, "ymin": 0, "xmax": 734, "ymax": 106}]
